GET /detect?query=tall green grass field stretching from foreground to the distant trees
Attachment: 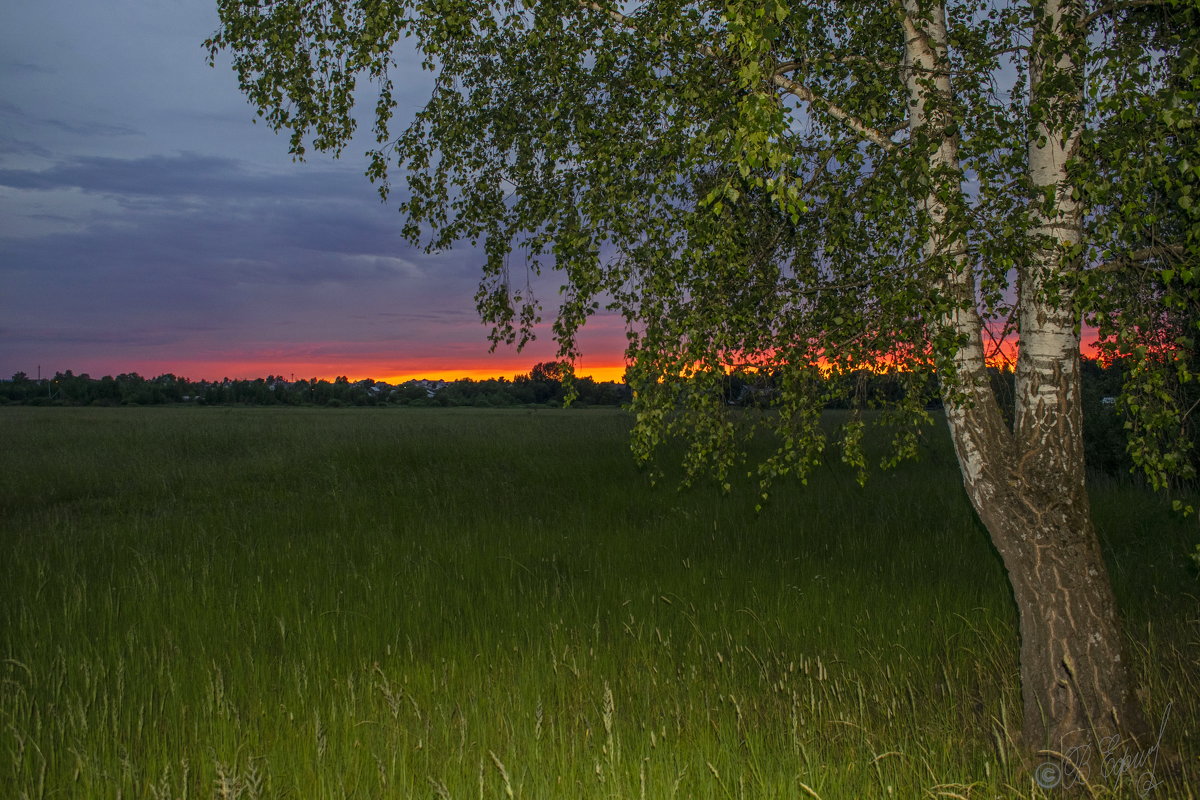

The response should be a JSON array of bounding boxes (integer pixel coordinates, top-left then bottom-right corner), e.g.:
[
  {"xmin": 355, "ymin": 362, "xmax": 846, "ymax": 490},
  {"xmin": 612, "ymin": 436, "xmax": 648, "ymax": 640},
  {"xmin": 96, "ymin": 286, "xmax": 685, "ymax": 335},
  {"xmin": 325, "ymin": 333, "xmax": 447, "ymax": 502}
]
[{"xmin": 0, "ymin": 408, "xmax": 1200, "ymax": 800}]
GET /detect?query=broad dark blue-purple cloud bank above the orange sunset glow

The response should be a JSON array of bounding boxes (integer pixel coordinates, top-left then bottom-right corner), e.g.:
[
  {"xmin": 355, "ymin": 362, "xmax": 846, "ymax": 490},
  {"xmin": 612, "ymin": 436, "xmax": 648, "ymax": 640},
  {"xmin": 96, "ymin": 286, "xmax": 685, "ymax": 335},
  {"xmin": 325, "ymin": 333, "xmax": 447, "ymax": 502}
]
[{"xmin": 0, "ymin": 148, "xmax": 486, "ymax": 368}]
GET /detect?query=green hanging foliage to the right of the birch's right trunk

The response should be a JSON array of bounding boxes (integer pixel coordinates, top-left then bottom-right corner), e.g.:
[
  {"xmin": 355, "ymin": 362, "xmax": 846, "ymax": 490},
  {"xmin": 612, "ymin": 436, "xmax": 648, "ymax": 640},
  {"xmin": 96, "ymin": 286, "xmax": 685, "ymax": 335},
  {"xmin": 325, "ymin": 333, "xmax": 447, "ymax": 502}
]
[{"xmin": 1075, "ymin": 0, "xmax": 1200, "ymax": 487}]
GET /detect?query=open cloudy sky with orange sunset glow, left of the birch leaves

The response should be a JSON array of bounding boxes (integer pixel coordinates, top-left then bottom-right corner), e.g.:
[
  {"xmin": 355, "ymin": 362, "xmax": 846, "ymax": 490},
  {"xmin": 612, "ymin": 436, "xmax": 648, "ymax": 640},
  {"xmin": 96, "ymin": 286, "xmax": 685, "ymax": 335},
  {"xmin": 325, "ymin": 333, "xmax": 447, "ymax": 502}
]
[{"xmin": 0, "ymin": 0, "xmax": 625, "ymax": 381}]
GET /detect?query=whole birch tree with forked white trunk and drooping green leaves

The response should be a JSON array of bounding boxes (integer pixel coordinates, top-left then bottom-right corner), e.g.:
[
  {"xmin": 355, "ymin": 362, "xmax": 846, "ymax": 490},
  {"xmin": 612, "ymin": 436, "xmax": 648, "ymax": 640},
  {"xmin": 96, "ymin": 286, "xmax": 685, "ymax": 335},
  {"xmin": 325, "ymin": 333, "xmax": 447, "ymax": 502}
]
[{"xmin": 206, "ymin": 0, "xmax": 1200, "ymax": 753}]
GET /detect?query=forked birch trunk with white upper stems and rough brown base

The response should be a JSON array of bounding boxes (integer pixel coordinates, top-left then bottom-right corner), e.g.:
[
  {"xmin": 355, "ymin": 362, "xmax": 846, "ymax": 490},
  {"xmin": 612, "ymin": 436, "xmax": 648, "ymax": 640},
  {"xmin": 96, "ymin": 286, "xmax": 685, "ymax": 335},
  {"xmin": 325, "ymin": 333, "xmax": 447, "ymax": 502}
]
[{"xmin": 904, "ymin": 0, "xmax": 1148, "ymax": 756}]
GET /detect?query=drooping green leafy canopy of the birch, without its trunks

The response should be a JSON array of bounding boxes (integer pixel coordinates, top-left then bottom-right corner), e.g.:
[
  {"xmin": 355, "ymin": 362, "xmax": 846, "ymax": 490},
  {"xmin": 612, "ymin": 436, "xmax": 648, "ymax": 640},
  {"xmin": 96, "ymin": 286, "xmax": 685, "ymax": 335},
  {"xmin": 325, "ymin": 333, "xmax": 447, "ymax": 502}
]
[{"xmin": 208, "ymin": 0, "xmax": 1200, "ymax": 496}]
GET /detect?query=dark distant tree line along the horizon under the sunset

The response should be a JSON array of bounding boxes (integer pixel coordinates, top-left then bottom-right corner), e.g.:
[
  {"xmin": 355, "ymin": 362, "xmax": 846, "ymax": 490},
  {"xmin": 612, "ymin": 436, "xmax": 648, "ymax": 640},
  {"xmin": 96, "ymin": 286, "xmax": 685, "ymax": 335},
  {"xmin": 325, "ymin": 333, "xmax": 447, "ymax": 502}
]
[{"xmin": 0, "ymin": 359, "xmax": 1180, "ymax": 476}]
